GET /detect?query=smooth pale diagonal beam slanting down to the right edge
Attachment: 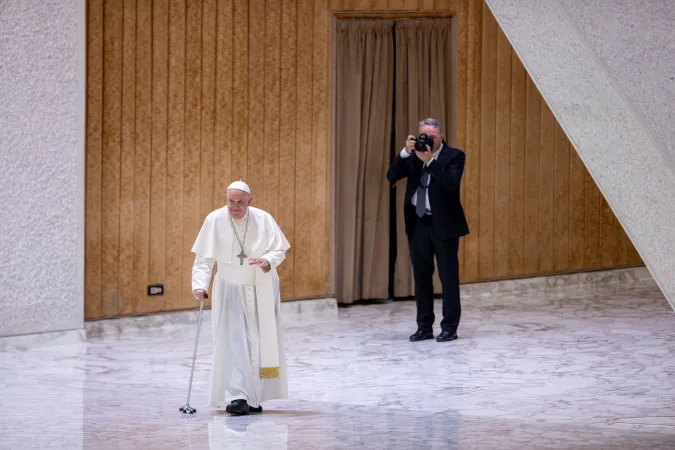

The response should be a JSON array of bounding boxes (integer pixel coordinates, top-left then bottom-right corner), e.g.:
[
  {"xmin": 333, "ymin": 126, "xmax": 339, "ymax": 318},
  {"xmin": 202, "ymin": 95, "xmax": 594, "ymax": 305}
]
[{"xmin": 486, "ymin": 0, "xmax": 675, "ymax": 309}]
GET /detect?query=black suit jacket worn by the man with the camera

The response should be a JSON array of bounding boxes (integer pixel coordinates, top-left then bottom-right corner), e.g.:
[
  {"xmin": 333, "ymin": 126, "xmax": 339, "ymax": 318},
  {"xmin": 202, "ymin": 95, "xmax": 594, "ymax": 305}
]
[{"xmin": 387, "ymin": 141, "xmax": 469, "ymax": 239}]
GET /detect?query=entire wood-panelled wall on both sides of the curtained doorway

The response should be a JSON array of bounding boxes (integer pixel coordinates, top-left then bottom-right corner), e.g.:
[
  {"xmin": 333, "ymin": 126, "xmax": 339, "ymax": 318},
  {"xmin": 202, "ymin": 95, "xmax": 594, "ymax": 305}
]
[{"xmin": 85, "ymin": 0, "xmax": 641, "ymax": 319}]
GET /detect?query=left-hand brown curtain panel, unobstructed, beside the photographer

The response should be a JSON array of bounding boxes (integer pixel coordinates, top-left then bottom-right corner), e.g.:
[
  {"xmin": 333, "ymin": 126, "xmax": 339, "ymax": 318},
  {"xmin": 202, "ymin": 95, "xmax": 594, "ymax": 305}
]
[{"xmin": 335, "ymin": 20, "xmax": 394, "ymax": 303}]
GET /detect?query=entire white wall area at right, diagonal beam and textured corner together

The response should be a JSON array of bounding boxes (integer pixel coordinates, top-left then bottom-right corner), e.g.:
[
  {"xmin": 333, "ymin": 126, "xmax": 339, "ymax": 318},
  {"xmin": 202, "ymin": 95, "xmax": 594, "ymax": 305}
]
[{"xmin": 486, "ymin": 0, "xmax": 675, "ymax": 308}]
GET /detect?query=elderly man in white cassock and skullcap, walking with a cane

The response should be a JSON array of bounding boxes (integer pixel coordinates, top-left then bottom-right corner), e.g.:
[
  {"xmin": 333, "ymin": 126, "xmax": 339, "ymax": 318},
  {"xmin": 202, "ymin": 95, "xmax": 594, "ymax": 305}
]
[{"xmin": 192, "ymin": 181, "xmax": 290, "ymax": 415}]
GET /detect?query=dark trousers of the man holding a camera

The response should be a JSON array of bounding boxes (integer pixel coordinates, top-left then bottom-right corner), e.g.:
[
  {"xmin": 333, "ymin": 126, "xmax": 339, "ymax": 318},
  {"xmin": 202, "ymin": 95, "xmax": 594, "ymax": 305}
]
[{"xmin": 408, "ymin": 215, "xmax": 462, "ymax": 333}]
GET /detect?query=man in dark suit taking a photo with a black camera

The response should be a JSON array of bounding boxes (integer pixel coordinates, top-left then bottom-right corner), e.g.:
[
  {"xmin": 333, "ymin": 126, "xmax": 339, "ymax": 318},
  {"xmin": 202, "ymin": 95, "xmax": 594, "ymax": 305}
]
[{"xmin": 387, "ymin": 119, "xmax": 469, "ymax": 342}]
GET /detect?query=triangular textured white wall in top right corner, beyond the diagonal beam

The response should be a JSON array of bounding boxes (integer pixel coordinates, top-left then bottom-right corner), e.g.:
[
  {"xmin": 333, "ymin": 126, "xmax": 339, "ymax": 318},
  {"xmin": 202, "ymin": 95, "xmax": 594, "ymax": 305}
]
[{"xmin": 559, "ymin": 0, "xmax": 675, "ymax": 176}]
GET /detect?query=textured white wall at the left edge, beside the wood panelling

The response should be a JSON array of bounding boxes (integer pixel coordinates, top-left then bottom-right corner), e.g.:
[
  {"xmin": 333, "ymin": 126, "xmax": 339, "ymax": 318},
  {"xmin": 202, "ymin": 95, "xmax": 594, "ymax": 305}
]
[{"xmin": 0, "ymin": 0, "xmax": 86, "ymax": 336}]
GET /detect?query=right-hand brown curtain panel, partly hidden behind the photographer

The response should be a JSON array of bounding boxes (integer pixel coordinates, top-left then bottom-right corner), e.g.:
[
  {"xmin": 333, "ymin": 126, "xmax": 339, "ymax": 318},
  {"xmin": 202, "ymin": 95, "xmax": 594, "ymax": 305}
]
[{"xmin": 394, "ymin": 19, "xmax": 457, "ymax": 297}]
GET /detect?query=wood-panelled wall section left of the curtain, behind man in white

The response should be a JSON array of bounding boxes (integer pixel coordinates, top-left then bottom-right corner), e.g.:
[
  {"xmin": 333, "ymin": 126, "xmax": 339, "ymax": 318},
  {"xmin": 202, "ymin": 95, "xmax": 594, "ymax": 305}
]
[{"xmin": 85, "ymin": 0, "xmax": 330, "ymax": 319}]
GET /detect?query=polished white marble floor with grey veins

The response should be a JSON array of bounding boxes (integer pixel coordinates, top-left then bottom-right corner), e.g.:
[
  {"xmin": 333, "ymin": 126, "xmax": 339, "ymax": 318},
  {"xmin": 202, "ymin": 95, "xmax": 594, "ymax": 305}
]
[{"xmin": 0, "ymin": 283, "xmax": 675, "ymax": 450}]
